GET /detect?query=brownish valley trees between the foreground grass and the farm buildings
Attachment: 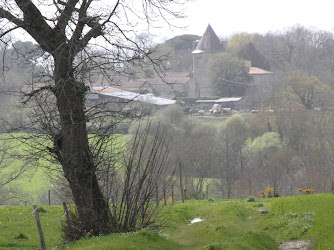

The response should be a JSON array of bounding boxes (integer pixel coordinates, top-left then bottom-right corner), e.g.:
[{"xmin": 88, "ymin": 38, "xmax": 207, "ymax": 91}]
[{"xmin": 148, "ymin": 102, "xmax": 334, "ymax": 199}]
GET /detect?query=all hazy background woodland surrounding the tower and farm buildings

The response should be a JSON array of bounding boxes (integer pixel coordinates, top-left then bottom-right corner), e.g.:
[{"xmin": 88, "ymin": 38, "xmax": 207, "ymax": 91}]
[{"xmin": 0, "ymin": 26, "xmax": 334, "ymax": 203}]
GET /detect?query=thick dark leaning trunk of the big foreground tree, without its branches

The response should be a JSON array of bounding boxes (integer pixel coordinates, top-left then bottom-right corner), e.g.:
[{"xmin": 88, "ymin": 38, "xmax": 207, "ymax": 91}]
[{"xmin": 54, "ymin": 53, "xmax": 115, "ymax": 234}]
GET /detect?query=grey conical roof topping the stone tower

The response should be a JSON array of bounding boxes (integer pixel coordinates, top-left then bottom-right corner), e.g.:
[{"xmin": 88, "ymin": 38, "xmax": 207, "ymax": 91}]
[{"xmin": 192, "ymin": 24, "xmax": 222, "ymax": 53}]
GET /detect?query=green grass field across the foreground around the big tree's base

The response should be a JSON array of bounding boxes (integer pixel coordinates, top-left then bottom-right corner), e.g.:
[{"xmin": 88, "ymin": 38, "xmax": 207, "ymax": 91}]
[{"xmin": 0, "ymin": 194, "xmax": 334, "ymax": 249}]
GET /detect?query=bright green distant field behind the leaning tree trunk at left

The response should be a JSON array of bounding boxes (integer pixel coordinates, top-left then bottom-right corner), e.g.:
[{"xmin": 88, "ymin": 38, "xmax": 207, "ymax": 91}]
[{"xmin": 0, "ymin": 133, "xmax": 129, "ymax": 205}]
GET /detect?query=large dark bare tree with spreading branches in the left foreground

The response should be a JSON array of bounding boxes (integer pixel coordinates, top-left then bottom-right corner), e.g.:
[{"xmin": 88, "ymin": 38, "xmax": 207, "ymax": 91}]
[{"xmin": 0, "ymin": 0, "xmax": 187, "ymax": 234}]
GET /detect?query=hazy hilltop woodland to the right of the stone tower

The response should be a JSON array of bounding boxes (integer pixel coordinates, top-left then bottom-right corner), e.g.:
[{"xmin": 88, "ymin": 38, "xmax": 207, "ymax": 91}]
[{"xmin": 228, "ymin": 25, "xmax": 334, "ymax": 108}]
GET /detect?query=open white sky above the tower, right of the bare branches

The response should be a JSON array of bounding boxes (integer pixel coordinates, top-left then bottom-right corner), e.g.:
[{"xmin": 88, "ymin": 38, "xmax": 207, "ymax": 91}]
[{"xmin": 155, "ymin": 0, "xmax": 334, "ymax": 38}]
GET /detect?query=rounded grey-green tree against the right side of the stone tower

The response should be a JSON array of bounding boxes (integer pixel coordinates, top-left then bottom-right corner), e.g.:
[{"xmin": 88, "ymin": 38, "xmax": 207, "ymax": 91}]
[{"xmin": 209, "ymin": 53, "xmax": 250, "ymax": 97}]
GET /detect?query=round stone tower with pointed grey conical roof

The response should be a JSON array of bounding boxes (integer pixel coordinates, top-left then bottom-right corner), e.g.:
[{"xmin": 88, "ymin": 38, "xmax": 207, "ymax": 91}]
[{"xmin": 189, "ymin": 24, "xmax": 224, "ymax": 98}]
